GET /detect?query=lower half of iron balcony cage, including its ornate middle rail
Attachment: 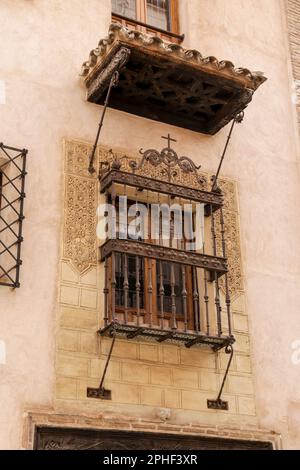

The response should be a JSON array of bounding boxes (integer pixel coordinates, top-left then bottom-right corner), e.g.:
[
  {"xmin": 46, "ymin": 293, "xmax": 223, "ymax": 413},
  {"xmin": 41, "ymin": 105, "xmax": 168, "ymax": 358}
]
[{"xmin": 100, "ymin": 202, "xmax": 234, "ymax": 349}]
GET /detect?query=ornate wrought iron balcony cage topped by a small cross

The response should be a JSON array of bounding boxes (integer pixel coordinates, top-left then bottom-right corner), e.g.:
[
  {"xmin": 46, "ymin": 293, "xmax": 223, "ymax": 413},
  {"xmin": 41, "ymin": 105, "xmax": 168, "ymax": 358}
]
[{"xmin": 87, "ymin": 134, "xmax": 240, "ymax": 410}]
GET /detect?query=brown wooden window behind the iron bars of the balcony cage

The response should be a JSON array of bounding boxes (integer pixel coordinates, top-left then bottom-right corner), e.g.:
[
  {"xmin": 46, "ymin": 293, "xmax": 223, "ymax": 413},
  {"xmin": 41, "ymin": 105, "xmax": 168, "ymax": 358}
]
[{"xmin": 109, "ymin": 198, "xmax": 197, "ymax": 326}]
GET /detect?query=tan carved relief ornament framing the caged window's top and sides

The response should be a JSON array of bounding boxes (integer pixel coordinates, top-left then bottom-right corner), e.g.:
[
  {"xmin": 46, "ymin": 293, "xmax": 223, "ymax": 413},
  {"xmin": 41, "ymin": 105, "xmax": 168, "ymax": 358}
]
[{"xmin": 63, "ymin": 141, "xmax": 243, "ymax": 296}]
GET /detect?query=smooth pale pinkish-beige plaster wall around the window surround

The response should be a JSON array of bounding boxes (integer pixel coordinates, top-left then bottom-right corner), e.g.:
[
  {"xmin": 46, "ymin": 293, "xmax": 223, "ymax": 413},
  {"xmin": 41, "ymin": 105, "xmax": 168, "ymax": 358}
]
[{"xmin": 0, "ymin": 0, "xmax": 300, "ymax": 448}]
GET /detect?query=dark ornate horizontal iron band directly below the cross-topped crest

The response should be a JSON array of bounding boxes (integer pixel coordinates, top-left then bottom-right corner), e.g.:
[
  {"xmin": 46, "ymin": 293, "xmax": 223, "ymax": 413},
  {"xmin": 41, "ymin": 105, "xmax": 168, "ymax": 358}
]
[{"xmin": 100, "ymin": 170, "xmax": 223, "ymax": 208}]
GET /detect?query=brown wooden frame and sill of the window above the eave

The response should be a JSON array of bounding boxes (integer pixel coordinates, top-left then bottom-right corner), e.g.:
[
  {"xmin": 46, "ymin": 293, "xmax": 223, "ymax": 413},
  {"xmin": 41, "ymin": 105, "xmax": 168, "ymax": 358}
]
[{"xmin": 112, "ymin": 0, "xmax": 184, "ymax": 43}]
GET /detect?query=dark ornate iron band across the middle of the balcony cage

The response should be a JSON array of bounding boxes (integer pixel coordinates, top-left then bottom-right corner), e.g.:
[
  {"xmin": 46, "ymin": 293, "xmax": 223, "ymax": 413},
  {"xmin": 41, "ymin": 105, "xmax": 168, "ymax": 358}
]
[{"xmin": 100, "ymin": 239, "xmax": 227, "ymax": 275}]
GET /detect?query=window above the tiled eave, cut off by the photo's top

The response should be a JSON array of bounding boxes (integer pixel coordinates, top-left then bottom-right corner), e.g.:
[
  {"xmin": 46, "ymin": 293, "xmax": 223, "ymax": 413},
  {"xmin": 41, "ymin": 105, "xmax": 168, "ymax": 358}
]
[{"xmin": 112, "ymin": 0, "xmax": 179, "ymax": 39}]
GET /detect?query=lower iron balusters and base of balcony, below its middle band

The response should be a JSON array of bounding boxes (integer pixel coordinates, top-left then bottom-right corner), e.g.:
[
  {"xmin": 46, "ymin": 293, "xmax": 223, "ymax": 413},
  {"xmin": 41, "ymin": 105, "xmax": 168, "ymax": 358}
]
[{"xmin": 100, "ymin": 252, "xmax": 233, "ymax": 349}]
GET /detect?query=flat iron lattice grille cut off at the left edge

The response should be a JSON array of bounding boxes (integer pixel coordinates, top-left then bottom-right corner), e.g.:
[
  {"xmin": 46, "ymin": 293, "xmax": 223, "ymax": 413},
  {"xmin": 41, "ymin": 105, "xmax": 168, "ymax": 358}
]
[{"xmin": 0, "ymin": 143, "xmax": 28, "ymax": 288}]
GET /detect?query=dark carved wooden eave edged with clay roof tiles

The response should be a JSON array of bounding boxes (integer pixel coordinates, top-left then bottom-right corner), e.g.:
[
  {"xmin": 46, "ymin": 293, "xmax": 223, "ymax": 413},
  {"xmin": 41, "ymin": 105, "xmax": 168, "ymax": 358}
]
[{"xmin": 82, "ymin": 24, "xmax": 266, "ymax": 134}]
